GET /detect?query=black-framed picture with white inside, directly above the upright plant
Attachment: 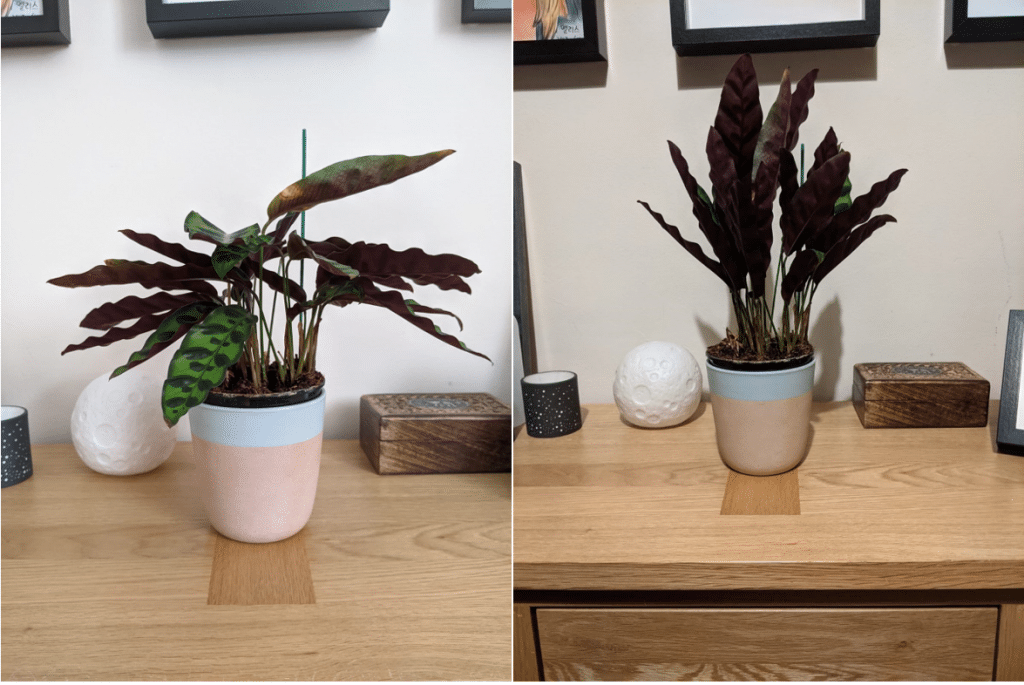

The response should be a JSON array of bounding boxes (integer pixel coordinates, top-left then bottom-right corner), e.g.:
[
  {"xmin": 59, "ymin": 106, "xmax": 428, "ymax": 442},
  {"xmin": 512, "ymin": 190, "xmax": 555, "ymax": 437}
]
[{"xmin": 670, "ymin": 0, "xmax": 880, "ymax": 55}]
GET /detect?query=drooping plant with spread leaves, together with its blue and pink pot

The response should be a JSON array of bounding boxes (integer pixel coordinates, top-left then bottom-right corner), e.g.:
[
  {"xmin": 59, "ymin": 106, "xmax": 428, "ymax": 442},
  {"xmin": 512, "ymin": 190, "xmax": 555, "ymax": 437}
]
[{"xmin": 49, "ymin": 149, "xmax": 487, "ymax": 542}]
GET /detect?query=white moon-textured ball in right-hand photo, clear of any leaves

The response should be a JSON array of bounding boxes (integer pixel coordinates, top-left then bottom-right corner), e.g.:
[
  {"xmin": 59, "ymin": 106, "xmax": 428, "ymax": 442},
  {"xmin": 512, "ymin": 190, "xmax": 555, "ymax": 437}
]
[{"xmin": 611, "ymin": 341, "xmax": 703, "ymax": 428}]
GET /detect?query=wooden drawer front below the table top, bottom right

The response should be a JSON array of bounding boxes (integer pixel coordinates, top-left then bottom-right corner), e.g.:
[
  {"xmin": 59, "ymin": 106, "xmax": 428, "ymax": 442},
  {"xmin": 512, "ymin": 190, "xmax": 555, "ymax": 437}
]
[{"xmin": 537, "ymin": 607, "xmax": 998, "ymax": 681}]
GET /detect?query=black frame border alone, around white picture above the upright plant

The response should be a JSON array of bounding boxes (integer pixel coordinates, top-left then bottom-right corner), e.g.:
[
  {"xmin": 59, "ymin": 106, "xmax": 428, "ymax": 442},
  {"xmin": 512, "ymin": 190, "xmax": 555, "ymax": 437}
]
[{"xmin": 670, "ymin": 0, "xmax": 881, "ymax": 56}]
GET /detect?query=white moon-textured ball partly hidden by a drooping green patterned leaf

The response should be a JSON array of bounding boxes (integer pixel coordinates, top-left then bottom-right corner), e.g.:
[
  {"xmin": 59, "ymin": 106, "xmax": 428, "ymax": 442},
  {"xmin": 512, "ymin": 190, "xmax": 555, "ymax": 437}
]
[{"xmin": 71, "ymin": 369, "xmax": 177, "ymax": 476}]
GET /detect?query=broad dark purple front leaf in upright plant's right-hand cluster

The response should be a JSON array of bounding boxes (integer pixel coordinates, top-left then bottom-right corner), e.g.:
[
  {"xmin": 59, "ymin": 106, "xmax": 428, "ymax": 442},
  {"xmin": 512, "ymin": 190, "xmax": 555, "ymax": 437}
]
[{"xmin": 779, "ymin": 153, "xmax": 850, "ymax": 254}]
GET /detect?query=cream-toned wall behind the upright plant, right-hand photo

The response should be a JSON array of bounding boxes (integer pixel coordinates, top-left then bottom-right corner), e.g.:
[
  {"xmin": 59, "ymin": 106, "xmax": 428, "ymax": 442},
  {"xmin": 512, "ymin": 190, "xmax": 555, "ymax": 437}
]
[{"xmin": 513, "ymin": 0, "xmax": 1024, "ymax": 402}]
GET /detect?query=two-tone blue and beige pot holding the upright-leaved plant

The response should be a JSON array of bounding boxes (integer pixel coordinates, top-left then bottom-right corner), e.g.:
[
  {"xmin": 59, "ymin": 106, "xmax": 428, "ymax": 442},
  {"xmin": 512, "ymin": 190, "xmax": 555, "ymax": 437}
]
[{"xmin": 708, "ymin": 356, "xmax": 814, "ymax": 476}]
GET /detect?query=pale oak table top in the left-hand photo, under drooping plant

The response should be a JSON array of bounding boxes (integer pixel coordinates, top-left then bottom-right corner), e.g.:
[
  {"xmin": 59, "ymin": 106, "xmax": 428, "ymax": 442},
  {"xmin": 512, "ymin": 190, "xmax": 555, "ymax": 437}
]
[{"xmin": 2, "ymin": 440, "xmax": 511, "ymax": 681}]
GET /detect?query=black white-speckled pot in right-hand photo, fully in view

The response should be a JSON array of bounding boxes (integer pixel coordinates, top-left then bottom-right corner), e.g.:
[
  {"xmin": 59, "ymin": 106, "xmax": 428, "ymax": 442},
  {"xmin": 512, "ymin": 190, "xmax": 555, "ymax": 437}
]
[{"xmin": 520, "ymin": 371, "xmax": 583, "ymax": 437}]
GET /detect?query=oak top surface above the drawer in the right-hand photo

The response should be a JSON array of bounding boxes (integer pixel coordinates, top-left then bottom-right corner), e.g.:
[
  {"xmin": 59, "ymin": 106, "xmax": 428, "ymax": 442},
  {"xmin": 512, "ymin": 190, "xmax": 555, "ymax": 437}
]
[{"xmin": 513, "ymin": 402, "xmax": 1024, "ymax": 591}]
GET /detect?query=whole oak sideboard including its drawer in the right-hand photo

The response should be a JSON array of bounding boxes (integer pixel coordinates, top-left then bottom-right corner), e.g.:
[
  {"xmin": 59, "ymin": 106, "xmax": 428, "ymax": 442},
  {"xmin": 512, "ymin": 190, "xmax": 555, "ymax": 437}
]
[{"xmin": 513, "ymin": 402, "xmax": 1024, "ymax": 681}]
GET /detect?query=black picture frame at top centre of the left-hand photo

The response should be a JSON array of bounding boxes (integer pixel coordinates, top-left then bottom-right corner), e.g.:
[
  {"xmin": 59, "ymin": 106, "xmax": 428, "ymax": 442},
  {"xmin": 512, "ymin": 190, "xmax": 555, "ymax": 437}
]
[{"xmin": 145, "ymin": 0, "xmax": 390, "ymax": 38}]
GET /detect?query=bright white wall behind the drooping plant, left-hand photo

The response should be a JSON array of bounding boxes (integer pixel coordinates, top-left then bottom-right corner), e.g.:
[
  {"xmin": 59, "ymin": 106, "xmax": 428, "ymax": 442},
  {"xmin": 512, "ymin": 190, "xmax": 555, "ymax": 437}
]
[{"xmin": 0, "ymin": 0, "xmax": 512, "ymax": 442}]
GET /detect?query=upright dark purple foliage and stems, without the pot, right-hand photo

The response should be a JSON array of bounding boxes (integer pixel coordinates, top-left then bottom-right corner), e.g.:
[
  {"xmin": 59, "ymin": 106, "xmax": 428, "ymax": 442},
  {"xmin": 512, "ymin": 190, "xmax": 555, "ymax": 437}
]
[{"xmin": 640, "ymin": 55, "xmax": 906, "ymax": 360}]
